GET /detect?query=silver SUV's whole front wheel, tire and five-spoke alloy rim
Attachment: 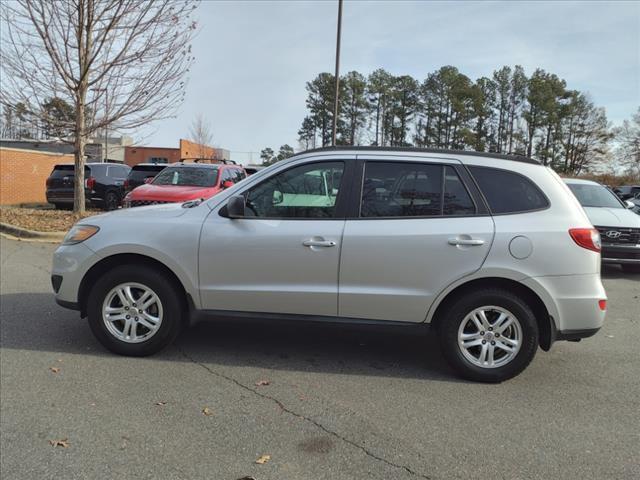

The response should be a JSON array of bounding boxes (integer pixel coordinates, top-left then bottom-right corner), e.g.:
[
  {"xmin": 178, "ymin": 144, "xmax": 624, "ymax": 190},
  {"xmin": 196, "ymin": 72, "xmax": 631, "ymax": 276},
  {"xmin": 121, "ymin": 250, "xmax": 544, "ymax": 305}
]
[{"xmin": 87, "ymin": 265, "xmax": 184, "ymax": 357}]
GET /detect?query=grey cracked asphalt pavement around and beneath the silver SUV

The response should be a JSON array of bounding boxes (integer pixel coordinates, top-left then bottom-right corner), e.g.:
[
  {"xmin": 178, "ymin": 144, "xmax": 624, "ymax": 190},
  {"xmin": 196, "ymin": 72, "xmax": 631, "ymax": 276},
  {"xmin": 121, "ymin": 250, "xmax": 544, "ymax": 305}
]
[{"xmin": 0, "ymin": 238, "xmax": 640, "ymax": 480}]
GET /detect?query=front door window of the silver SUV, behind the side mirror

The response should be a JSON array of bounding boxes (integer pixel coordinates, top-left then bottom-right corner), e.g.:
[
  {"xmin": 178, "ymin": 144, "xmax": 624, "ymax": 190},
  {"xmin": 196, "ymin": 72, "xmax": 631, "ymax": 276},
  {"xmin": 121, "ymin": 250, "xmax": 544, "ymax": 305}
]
[{"xmin": 247, "ymin": 162, "xmax": 344, "ymax": 218}]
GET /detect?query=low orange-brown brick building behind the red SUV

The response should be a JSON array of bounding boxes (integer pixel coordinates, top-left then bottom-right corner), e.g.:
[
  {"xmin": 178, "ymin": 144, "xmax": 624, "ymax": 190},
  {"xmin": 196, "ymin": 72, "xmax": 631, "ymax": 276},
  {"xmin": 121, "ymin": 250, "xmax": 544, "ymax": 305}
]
[{"xmin": 124, "ymin": 138, "xmax": 230, "ymax": 167}]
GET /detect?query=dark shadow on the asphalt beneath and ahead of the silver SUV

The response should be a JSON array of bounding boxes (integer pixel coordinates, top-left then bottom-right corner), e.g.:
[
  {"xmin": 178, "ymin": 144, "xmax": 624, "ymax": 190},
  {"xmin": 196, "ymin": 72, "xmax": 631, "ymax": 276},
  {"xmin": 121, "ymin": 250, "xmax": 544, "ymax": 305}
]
[{"xmin": 0, "ymin": 293, "xmax": 463, "ymax": 382}]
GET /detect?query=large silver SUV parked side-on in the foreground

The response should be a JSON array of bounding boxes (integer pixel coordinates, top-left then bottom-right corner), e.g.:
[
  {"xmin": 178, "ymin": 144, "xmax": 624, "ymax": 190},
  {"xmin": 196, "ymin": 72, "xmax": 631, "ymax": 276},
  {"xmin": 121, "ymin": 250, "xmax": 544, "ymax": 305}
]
[{"xmin": 52, "ymin": 147, "xmax": 606, "ymax": 382}]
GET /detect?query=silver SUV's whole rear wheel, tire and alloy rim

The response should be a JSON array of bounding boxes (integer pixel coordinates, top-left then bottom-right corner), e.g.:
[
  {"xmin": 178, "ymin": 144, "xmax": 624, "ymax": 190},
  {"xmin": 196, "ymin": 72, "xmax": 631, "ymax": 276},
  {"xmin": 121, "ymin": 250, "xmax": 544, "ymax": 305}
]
[{"xmin": 438, "ymin": 289, "xmax": 538, "ymax": 382}]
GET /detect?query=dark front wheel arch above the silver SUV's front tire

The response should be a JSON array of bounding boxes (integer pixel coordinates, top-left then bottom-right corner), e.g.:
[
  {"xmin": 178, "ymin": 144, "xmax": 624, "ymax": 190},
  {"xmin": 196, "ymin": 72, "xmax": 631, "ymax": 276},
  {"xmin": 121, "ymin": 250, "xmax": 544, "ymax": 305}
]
[{"xmin": 78, "ymin": 253, "xmax": 194, "ymax": 318}]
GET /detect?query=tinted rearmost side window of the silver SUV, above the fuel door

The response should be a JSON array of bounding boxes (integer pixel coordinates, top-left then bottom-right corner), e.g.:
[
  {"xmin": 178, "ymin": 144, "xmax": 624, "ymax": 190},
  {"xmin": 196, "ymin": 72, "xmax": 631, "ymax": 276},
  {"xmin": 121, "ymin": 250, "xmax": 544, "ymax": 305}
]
[{"xmin": 469, "ymin": 167, "xmax": 549, "ymax": 213}]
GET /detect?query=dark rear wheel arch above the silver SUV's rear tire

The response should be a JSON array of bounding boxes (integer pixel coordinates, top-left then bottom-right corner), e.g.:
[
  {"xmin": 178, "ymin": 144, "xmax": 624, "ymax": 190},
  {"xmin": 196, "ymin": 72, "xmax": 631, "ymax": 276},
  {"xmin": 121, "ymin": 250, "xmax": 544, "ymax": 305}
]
[{"xmin": 427, "ymin": 277, "xmax": 556, "ymax": 351}]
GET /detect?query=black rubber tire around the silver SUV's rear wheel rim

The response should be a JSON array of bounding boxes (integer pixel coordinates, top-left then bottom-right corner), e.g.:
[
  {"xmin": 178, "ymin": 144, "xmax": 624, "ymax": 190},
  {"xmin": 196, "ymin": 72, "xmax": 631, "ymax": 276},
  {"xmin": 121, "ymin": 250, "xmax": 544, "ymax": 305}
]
[{"xmin": 437, "ymin": 289, "xmax": 539, "ymax": 383}]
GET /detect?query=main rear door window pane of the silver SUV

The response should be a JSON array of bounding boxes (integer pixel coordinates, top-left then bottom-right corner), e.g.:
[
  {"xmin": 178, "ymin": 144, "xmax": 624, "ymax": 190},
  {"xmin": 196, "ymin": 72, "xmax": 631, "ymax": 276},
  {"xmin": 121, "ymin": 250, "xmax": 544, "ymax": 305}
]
[{"xmin": 360, "ymin": 162, "xmax": 442, "ymax": 217}]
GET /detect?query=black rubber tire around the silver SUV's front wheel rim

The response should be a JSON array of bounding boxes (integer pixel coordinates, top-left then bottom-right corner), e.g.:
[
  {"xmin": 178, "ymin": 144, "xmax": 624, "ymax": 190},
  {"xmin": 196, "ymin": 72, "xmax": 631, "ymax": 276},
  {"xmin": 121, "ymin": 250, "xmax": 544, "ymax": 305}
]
[{"xmin": 87, "ymin": 264, "xmax": 185, "ymax": 357}]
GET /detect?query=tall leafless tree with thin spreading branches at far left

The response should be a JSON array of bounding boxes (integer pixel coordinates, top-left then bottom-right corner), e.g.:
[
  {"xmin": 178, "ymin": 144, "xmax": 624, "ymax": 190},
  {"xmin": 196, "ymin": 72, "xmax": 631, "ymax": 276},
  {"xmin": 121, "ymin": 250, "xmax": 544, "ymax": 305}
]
[{"xmin": 0, "ymin": 0, "xmax": 197, "ymax": 214}]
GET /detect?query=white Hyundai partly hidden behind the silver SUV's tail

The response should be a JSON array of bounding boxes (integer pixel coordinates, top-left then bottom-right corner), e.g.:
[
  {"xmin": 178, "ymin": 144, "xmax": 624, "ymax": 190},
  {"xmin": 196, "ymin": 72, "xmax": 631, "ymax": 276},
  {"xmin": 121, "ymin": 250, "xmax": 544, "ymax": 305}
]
[{"xmin": 565, "ymin": 178, "xmax": 640, "ymax": 273}]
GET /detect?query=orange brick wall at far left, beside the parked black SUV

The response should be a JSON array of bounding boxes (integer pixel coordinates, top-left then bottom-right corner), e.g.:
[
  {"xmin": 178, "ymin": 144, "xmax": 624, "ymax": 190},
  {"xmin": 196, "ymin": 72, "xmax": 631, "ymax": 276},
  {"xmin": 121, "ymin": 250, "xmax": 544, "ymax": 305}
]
[{"xmin": 0, "ymin": 146, "xmax": 73, "ymax": 205}]
